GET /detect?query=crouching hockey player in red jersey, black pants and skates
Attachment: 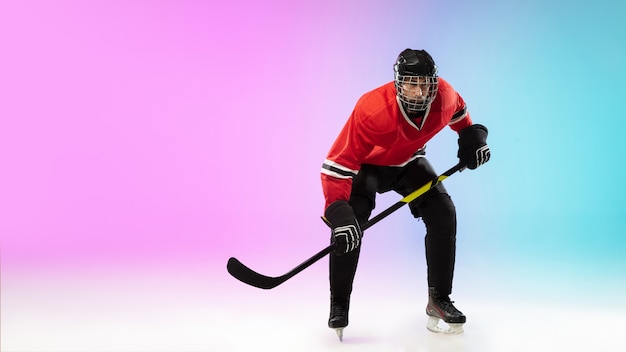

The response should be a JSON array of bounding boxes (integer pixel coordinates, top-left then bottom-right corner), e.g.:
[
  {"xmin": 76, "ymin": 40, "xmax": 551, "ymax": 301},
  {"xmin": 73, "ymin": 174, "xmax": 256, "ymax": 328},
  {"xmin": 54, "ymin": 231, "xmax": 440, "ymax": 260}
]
[{"xmin": 321, "ymin": 49, "xmax": 490, "ymax": 339}]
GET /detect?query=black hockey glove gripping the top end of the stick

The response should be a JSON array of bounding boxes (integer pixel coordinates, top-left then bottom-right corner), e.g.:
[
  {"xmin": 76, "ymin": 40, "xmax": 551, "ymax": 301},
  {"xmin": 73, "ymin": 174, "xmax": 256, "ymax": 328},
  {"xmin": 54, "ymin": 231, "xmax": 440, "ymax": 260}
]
[{"xmin": 457, "ymin": 124, "xmax": 491, "ymax": 170}]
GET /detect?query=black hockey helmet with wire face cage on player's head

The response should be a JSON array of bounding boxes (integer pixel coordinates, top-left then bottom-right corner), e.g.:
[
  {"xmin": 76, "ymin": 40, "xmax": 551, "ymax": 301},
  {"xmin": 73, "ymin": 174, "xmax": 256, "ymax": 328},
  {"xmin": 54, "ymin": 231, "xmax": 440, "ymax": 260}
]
[{"xmin": 393, "ymin": 49, "xmax": 439, "ymax": 113}]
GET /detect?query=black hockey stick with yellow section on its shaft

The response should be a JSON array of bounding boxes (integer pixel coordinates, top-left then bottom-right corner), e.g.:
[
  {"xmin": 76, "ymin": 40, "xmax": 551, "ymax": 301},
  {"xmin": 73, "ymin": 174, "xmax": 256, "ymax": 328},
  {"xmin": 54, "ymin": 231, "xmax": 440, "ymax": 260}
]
[{"xmin": 226, "ymin": 163, "xmax": 465, "ymax": 290}]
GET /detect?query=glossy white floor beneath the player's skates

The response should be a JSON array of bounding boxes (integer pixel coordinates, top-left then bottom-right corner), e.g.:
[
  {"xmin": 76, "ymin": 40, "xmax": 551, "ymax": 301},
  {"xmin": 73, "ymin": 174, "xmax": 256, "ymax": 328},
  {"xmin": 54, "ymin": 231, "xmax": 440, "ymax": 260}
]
[{"xmin": 0, "ymin": 269, "xmax": 626, "ymax": 352}]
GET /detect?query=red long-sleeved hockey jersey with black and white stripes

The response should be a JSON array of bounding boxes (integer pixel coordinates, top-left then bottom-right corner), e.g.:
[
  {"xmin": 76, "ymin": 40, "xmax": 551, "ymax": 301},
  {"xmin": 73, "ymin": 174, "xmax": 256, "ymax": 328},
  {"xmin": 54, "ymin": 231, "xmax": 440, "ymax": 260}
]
[{"xmin": 322, "ymin": 77, "xmax": 472, "ymax": 208}]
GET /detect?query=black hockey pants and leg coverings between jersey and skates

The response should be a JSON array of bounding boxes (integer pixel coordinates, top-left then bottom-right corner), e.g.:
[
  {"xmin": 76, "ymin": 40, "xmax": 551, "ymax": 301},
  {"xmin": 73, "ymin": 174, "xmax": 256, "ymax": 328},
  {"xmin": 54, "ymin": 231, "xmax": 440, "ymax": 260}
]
[{"xmin": 330, "ymin": 157, "xmax": 456, "ymax": 299}]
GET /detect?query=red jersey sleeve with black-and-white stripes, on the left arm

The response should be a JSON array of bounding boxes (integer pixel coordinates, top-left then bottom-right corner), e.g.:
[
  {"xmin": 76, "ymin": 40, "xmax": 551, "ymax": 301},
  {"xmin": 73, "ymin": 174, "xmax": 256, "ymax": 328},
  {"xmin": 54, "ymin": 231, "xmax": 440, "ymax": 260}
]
[{"xmin": 321, "ymin": 108, "xmax": 377, "ymax": 209}]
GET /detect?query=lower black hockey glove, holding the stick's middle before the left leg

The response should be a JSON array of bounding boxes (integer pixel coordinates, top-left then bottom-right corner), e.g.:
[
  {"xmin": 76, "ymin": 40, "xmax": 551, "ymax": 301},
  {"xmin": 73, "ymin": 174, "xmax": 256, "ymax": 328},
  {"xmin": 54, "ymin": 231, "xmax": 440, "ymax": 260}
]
[{"xmin": 324, "ymin": 200, "xmax": 363, "ymax": 255}]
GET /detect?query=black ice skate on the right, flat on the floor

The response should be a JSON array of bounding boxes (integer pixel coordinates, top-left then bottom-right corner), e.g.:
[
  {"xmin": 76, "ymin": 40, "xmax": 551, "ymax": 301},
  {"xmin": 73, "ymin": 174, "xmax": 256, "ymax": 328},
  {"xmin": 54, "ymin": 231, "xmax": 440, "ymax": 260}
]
[{"xmin": 426, "ymin": 287, "xmax": 465, "ymax": 334}]
